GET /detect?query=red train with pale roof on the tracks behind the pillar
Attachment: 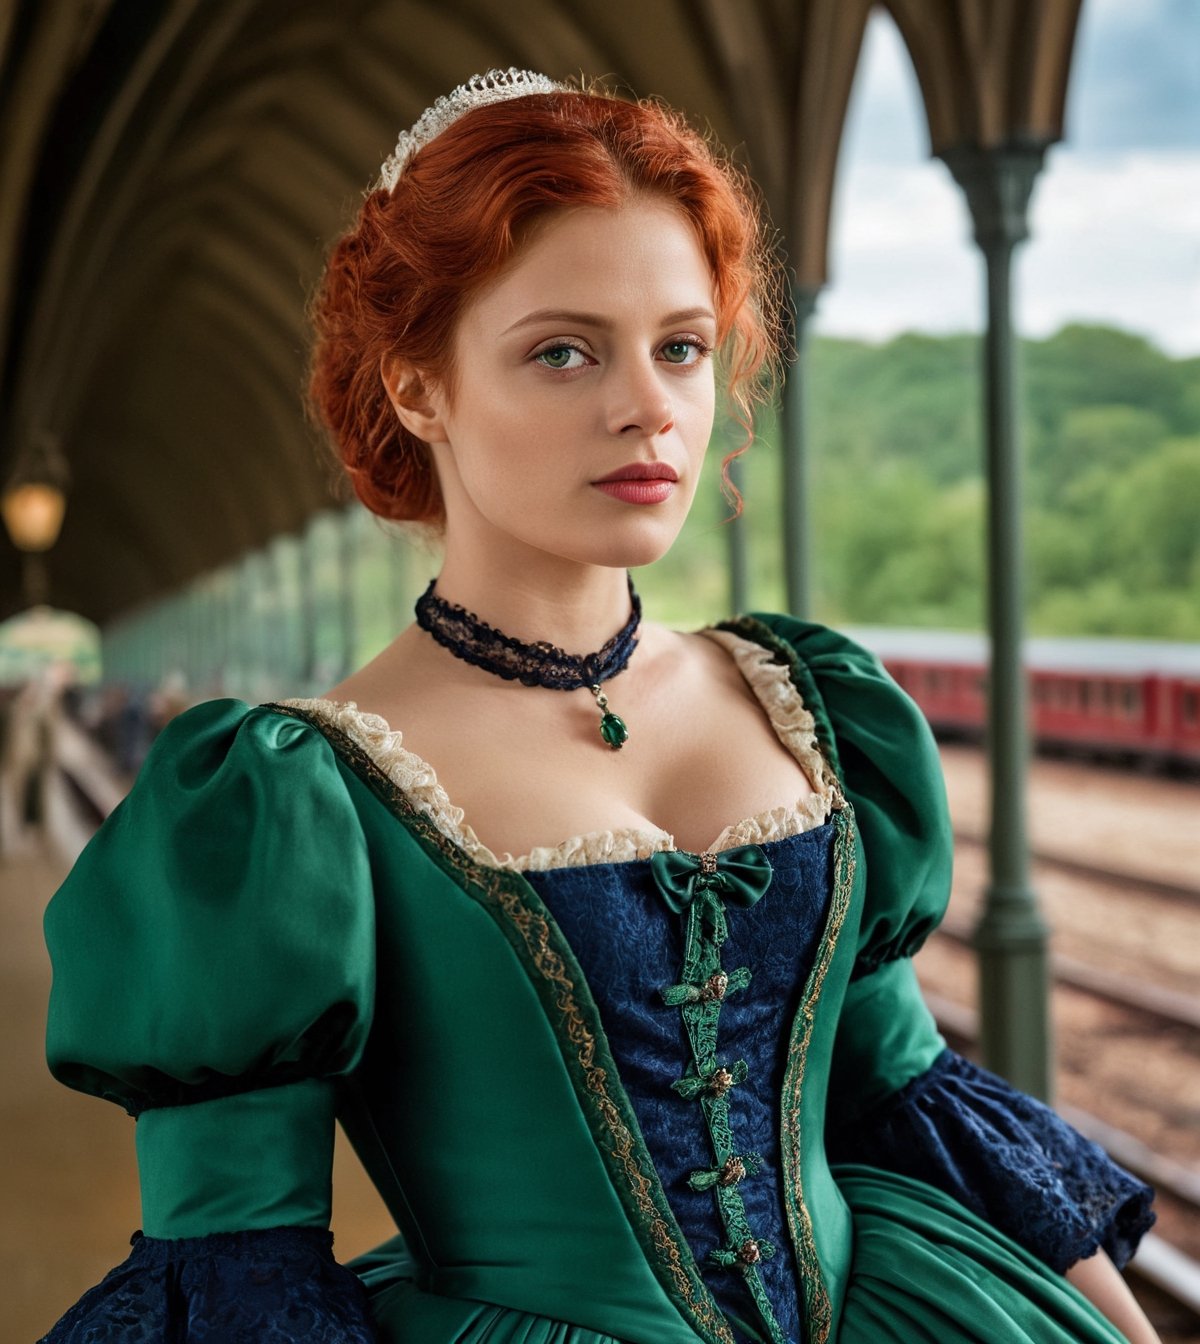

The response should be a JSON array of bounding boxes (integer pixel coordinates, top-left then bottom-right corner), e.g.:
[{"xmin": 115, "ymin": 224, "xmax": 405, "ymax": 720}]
[{"xmin": 851, "ymin": 628, "xmax": 1200, "ymax": 766}]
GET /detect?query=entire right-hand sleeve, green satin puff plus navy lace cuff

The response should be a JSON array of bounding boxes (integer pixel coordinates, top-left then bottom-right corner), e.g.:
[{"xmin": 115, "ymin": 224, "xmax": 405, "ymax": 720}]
[{"xmin": 752, "ymin": 621, "xmax": 1154, "ymax": 1271}]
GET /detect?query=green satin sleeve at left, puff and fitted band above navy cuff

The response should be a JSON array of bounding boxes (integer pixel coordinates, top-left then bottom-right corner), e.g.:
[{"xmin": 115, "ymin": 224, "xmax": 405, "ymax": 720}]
[{"xmin": 46, "ymin": 700, "xmax": 375, "ymax": 1238}]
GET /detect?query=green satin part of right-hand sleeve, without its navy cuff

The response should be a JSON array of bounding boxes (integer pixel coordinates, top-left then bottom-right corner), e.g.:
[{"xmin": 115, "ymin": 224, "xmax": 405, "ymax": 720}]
[{"xmin": 747, "ymin": 617, "xmax": 954, "ymax": 1124}]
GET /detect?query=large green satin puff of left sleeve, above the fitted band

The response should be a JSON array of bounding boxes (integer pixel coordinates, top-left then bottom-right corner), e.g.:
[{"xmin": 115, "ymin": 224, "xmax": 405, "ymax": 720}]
[{"xmin": 46, "ymin": 700, "xmax": 375, "ymax": 1114}]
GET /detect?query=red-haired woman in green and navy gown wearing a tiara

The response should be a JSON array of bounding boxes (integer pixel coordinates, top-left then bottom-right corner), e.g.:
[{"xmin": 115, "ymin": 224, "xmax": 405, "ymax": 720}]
[{"xmin": 47, "ymin": 71, "xmax": 1154, "ymax": 1344}]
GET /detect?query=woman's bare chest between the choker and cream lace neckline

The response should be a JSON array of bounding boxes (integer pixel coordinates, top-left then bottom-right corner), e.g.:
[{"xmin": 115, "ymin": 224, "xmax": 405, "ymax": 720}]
[{"xmin": 389, "ymin": 650, "xmax": 812, "ymax": 855}]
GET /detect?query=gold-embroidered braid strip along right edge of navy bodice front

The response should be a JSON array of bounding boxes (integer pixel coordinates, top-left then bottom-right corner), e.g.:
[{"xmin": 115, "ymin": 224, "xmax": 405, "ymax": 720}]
[{"xmin": 781, "ymin": 804, "xmax": 855, "ymax": 1344}]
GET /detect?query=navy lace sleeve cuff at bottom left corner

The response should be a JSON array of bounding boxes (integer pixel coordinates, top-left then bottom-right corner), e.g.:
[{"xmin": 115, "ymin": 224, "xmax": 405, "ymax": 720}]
[{"xmin": 39, "ymin": 1227, "xmax": 375, "ymax": 1344}]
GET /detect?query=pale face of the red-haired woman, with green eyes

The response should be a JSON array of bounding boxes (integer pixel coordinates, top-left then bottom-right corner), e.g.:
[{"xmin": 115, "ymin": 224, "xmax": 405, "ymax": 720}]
[{"xmin": 410, "ymin": 198, "xmax": 716, "ymax": 567}]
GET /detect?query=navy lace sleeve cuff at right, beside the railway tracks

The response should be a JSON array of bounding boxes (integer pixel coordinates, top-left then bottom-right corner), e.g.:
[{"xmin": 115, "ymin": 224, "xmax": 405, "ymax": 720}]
[{"xmin": 828, "ymin": 1050, "xmax": 1154, "ymax": 1273}]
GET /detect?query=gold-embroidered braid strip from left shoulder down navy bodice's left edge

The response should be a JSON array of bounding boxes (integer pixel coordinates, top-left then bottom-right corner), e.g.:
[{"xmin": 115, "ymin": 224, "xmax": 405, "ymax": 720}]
[{"xmin": 263, "ymin": 702, "xmax": 735, "ymax": 1344}]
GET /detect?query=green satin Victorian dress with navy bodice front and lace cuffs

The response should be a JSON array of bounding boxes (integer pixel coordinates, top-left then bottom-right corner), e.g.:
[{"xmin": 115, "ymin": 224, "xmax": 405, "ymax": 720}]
[{"xmin": 46, "ymin": 614, "xmax": 1153, "ymax": 1344}]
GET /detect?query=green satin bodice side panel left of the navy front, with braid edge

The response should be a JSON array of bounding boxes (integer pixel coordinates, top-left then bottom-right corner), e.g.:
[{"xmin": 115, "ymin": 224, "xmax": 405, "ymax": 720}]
[{"xmin": 330, "ymin": 774, "xmax": 715, "ymax": 1344}]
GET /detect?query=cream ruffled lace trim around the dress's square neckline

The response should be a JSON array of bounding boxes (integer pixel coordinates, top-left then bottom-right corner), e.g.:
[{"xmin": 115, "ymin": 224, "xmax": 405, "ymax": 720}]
[{"xmin": 278, "ymin": 629, "xmax": 839, "ymax": 872}]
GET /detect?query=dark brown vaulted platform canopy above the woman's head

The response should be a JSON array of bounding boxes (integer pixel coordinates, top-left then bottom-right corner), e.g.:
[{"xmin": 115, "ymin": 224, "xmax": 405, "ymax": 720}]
[{"xmin": 0, "ymin": 0, "xmax": 1079, "ymax": 622}]
